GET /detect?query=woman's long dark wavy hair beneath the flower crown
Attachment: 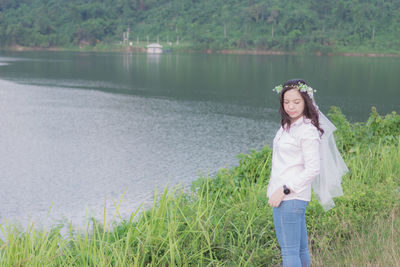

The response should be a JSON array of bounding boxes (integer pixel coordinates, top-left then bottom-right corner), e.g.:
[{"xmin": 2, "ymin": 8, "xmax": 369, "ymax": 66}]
[{"xmin": 279, "ymin": 79, "xmax": 324, "ymax": 135}]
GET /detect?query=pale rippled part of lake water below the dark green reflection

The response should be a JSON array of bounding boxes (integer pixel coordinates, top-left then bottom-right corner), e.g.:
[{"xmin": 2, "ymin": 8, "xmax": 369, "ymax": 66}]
[{"xmin": 0, "ymin": 81, "xmax": 278, "ymax": 230}]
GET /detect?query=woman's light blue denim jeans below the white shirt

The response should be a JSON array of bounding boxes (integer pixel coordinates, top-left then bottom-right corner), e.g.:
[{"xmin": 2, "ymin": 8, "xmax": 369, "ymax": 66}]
[{"xmin": 272, "ymin": 199, "xmax": 310, "ymax": 267}]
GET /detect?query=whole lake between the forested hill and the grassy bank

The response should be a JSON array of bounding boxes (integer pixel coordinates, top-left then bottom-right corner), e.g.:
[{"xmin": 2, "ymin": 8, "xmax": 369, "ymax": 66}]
[{"xmin": 0, "ymin": 52, "xmax": 400, "ymax": 229}]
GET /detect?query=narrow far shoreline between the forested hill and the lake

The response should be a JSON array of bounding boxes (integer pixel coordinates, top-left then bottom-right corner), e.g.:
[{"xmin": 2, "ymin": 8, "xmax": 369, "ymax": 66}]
[{"xmin": 1, "ymin": 45, "xmax": 400, "ymax": 57}]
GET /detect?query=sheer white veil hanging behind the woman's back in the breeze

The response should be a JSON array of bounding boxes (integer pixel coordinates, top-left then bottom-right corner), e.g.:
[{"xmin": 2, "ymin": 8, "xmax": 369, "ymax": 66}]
[{"xmin": 312, "ymin": 109, "xmax": 348, "ymax": 211}]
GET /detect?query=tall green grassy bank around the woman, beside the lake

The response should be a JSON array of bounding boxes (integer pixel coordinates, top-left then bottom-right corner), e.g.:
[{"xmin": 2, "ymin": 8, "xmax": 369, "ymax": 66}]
[{"xmin": 0, "ymin": 108, "xmax": 400, "ymax": 266}]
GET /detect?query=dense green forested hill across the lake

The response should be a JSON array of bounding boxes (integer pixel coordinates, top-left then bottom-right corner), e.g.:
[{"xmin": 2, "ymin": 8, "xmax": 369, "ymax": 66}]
[{"xmin": 0, "ymin": 0, "xmax": 400, "ymax": 53}]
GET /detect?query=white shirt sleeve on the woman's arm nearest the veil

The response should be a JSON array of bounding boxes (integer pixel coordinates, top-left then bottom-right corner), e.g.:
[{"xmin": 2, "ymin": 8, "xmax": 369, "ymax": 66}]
[{"xmin": 286, "ymin": 128, "xmax": 320, "ymax": 193}]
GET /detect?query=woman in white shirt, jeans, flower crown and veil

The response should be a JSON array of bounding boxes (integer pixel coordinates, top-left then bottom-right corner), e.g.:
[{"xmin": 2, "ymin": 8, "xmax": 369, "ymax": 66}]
[{"xmin": 267, "ymin": 80, "xmax": 347, "ymax": 267}]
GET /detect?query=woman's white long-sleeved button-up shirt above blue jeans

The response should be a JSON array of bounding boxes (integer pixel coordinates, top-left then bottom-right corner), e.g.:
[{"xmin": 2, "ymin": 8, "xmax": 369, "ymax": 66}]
[{"xmin": 267, "ymin": 117, "xmax": 321, "ymax": 201}]
